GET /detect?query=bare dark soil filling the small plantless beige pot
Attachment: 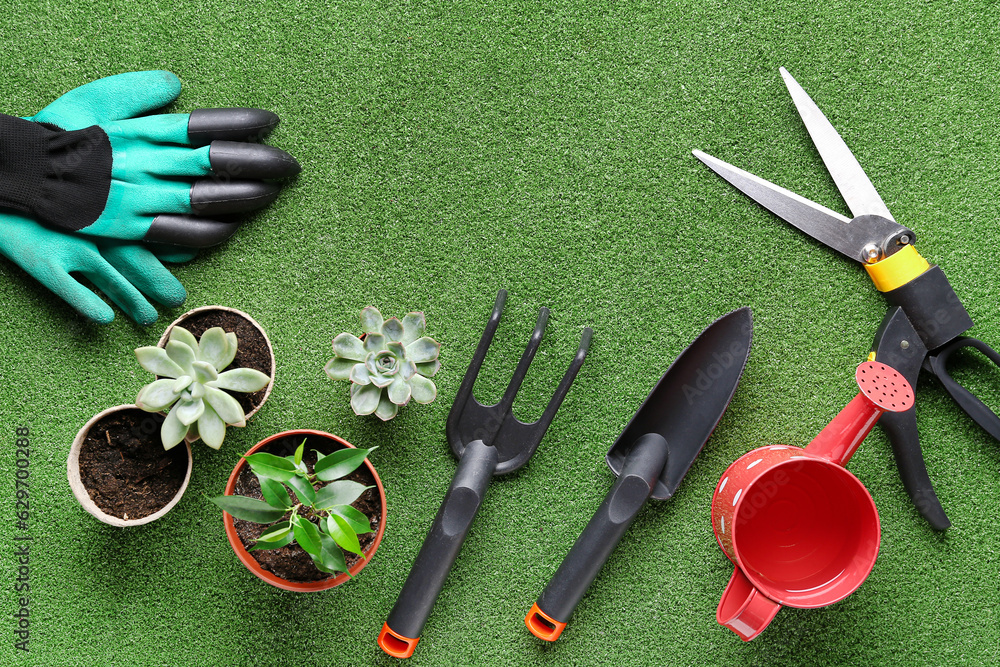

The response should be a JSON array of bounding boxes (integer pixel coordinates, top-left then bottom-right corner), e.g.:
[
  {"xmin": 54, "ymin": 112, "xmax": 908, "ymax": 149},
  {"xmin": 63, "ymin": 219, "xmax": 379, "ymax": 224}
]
[{"xmin": 80, "ymin": 408, "xmax": 188, "ymax": 519}]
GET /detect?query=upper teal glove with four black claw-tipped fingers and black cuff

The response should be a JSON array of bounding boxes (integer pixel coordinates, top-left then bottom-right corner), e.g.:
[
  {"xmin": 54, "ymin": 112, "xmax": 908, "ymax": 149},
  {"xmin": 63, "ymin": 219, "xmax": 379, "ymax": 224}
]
[{"xmin": 0, "ymin": 71, "xmax": 300, "ymax": 248}]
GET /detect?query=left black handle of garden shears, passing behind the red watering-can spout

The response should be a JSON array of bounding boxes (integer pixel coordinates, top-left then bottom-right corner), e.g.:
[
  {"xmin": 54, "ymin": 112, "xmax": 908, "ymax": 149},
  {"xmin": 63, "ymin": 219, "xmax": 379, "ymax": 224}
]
[{"xmin": 874, "ymin": 306, "xmax": 951, "ymax": 530}]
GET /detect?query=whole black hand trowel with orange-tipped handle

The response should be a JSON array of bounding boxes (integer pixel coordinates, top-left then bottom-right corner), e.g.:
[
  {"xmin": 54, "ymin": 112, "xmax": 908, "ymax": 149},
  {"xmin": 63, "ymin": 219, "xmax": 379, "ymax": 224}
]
[{"xmin": 524, "ymin": 307, "xmax": 753, "ymax": 641}]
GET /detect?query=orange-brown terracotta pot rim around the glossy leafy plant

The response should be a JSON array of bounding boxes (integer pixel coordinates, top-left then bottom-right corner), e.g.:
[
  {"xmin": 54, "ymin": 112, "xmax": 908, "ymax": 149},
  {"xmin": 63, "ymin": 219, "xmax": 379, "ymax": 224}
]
[{"xmin": 222, "ymin": 429, "xmax": 386, "ymax": 593}]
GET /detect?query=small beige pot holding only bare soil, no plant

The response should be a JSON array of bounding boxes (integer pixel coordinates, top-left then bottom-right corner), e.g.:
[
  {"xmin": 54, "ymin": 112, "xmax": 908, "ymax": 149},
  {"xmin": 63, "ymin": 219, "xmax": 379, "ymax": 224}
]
[{"xmin": 66, "ymin": 405, "xmax": 192, "ymax": 528}]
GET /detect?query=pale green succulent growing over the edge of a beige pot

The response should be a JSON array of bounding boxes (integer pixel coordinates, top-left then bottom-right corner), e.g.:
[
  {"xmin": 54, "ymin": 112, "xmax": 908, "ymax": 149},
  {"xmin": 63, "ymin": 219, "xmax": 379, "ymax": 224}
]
[{"xmin": 135, "ymin": 326, "xmax": 271, "ymax": 449}]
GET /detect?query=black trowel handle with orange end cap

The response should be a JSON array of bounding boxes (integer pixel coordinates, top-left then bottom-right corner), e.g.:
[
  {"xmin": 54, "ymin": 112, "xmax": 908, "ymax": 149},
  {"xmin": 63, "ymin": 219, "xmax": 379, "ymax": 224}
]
[{"xmin": 525, "ymin": 433, "xmax": 667, "ymax": 641}]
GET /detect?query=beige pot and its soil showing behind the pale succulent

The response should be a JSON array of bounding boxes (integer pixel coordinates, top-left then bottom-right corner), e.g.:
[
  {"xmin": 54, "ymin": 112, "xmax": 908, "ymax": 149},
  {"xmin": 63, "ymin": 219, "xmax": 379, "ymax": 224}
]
[{"xmin": 157, "ymin": 306, "xmax": 275, "ymax": 419}]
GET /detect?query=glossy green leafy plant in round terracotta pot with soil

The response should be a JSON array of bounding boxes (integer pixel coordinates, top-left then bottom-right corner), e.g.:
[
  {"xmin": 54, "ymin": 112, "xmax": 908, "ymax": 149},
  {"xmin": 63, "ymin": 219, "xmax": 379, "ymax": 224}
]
[{"xmin": 211, "ymin": 430, "xmax": 386, "ymax": 592}]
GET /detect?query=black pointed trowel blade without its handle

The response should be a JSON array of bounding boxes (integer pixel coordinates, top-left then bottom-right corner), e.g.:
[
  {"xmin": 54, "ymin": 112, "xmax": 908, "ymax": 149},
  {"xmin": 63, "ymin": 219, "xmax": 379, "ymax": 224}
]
[{"xmin": 606, "ymin": 307, "xmax": 753, "ymax": 500}]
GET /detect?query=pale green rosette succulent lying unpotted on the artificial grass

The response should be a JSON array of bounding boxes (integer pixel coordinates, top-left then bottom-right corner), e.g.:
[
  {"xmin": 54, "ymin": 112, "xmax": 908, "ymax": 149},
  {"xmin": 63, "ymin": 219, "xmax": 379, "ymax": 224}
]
[{"xmin": 325, "ymin": 306, "xmax": 441, "ymax": 421}]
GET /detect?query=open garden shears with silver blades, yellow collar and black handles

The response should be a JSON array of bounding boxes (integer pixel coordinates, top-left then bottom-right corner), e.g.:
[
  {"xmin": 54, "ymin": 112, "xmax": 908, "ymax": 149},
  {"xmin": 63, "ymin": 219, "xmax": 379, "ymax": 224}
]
[{"xmin": 694, "ymin": 68, "xmax": 1000, "ymax": 530}]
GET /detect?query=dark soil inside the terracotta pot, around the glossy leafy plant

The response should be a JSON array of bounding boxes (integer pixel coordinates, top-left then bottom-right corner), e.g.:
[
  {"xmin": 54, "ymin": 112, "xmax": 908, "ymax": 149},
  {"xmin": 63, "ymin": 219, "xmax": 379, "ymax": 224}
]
[{"xmin": 233, "ymin": 435, "xmax": 382, "ymax": 582}]
